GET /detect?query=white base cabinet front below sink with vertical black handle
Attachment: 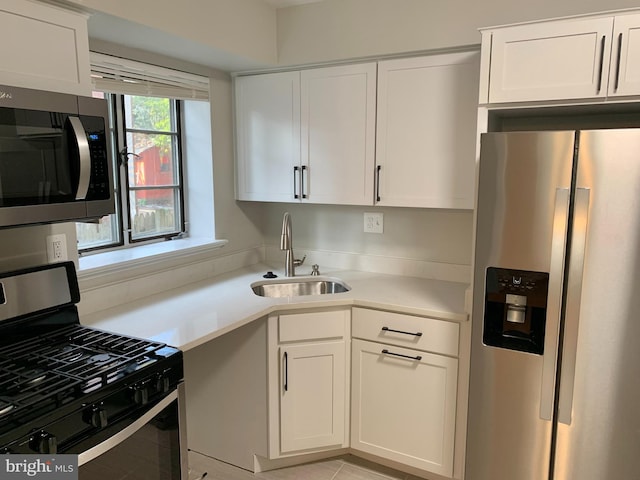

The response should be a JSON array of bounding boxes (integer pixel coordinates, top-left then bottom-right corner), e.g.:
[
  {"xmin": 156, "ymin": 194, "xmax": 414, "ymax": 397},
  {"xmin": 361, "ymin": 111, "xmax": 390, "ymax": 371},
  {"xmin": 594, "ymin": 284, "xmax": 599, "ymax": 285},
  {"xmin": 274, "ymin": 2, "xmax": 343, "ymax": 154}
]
[{"xmin": 268, "ymin": 309, "xmax": 350, "ymax": 459}]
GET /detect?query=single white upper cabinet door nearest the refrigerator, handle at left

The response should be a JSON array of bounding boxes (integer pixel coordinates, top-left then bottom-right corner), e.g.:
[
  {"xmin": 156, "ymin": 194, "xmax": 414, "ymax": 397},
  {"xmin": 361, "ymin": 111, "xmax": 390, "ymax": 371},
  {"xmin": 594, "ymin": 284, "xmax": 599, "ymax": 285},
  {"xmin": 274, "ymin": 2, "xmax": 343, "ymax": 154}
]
[{"xmin": 376, "ymin": 52, "xmax": 480, "ymax": 209}]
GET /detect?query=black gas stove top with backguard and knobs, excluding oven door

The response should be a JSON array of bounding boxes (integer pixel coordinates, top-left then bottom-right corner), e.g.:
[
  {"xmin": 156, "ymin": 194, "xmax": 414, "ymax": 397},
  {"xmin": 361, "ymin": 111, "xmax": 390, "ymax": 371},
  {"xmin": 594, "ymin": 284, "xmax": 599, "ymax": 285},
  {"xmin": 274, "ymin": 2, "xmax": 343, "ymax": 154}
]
[{"xmin": 0, "ymin": 262, "xmax": 183, "ymax": 462}]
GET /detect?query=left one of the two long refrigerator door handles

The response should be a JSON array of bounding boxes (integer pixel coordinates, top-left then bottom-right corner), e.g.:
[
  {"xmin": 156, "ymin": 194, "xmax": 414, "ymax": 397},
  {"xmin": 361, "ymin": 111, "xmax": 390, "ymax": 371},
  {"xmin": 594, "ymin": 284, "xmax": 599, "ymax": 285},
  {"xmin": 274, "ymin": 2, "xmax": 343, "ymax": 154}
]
[{"xmin": 540, "ymin": 188, "xmax": 570, "ymax": 421}]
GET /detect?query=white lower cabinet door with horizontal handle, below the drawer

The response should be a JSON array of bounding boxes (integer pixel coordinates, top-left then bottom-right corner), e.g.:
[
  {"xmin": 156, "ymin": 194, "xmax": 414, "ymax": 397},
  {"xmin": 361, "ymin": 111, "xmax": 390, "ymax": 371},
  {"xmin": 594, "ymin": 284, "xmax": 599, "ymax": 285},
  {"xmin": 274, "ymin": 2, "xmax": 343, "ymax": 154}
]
[{"xmin": 351, "ymin": 340, "xmax": 458, "ymax": 477}]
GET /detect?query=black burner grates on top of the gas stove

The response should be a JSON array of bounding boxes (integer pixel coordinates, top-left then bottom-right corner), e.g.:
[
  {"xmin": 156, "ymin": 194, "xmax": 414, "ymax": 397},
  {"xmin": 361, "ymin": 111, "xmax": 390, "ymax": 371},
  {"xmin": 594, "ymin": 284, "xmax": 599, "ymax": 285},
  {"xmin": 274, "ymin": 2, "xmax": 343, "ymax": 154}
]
[{"xmin": 0, "ymin": 324, "xmax": 165, "ymax": 421}]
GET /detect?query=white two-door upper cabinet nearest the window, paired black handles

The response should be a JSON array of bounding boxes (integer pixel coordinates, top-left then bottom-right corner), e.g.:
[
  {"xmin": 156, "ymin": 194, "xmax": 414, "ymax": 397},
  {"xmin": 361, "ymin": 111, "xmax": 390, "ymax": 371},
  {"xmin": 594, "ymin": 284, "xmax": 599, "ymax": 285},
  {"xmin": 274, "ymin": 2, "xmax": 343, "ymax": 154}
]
[{"xmin": 235, "ymin": 63, "xmax": 376, "ymax": 205}]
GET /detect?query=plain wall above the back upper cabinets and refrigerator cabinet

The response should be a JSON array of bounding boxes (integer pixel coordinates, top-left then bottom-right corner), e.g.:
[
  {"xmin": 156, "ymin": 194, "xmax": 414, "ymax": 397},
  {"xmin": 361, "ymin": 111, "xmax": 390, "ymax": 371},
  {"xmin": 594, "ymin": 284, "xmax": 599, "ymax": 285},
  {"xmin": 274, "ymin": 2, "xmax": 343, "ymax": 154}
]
[{"xmin": 277, "ymin": 0, "xmax": 639, "ymax": 65}]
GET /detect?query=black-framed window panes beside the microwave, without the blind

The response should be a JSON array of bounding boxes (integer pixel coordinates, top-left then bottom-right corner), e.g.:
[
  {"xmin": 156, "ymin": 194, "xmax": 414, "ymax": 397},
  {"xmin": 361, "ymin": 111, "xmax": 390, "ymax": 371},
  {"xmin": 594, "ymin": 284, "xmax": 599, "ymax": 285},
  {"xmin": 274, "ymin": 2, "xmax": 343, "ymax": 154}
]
[{"xmin": 76, "ymin": 95, "xmax": 184, "ymax": 252}]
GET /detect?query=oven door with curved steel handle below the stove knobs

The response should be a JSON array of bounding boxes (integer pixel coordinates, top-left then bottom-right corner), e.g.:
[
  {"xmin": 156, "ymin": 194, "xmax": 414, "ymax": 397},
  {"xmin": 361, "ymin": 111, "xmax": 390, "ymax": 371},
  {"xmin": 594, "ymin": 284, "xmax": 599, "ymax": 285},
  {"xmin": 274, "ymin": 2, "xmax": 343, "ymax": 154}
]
[{"xmin": 78, "ymin": 383, "xmax": 188, "ymax": 480}]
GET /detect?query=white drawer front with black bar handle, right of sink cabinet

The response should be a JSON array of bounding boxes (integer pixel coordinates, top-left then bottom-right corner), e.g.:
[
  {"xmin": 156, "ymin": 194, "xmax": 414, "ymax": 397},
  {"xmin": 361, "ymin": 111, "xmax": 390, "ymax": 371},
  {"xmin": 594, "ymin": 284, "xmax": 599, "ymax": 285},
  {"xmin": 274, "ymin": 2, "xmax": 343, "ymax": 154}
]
[{"xmin": 351, "ymin": 308, "xmax": 459, "ymax": 357}]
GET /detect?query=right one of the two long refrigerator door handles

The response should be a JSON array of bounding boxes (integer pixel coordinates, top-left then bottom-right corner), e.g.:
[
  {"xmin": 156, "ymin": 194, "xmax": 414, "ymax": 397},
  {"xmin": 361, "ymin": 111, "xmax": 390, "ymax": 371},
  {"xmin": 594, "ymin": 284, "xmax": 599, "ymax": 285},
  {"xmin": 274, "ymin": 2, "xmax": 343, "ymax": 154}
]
[{"xmin": 558, "ymin": 188, "xmax": 590, "ymax": 425}]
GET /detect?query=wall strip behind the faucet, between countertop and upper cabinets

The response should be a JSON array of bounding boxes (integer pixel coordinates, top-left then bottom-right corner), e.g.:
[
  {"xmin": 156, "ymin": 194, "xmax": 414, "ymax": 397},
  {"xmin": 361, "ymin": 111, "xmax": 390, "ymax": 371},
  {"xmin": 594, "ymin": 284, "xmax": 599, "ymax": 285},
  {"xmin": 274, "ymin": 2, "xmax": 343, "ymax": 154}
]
[{"xmin": 248, "ymin": 202, "xmax": 473, "ymax": 281}]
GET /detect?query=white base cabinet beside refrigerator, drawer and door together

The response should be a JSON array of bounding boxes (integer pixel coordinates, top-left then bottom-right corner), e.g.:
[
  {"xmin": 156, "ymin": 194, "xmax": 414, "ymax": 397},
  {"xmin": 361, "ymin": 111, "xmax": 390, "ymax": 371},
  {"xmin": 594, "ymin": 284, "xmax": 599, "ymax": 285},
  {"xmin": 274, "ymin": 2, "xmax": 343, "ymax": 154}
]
[{"xmin": 351, "ymin": 308, "xmax": 459, "ymax": 477}]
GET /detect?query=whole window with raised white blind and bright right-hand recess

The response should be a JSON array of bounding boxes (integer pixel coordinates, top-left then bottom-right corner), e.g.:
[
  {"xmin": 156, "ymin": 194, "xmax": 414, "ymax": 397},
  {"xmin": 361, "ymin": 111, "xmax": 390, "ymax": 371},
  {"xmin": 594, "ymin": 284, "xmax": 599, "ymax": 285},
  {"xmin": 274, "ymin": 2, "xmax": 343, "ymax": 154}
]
[{"xmin": 76, "ymin": 52, "xmax": 213, "ymax": 253}]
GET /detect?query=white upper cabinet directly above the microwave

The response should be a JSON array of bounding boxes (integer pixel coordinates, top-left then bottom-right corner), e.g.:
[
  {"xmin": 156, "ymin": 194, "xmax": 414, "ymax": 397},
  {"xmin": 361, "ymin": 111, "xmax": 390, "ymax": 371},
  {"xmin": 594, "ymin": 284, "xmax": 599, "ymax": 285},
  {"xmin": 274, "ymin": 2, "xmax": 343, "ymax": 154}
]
[{"xmin": 0, "ymin": 0, "xmax": 91, "ymax": 96}]
